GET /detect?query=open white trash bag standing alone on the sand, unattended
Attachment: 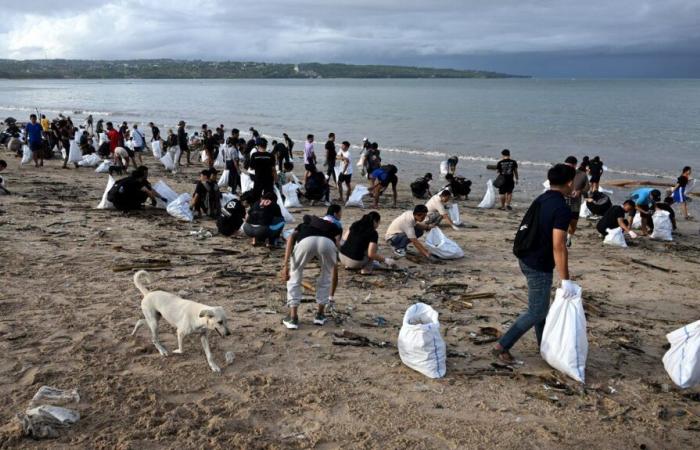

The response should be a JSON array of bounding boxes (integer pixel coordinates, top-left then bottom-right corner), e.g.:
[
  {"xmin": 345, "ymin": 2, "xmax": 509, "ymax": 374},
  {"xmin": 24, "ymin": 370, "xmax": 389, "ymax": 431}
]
[{"xmin": 398, "ymin": 303, "xmax": 447, "ymax": 378}]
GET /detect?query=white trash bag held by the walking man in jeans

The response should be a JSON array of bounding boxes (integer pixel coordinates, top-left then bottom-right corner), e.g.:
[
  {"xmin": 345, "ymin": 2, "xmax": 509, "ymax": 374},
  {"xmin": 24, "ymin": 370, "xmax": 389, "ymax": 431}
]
[{"xmin": 540, "ymin": 286, "xmax": 588, "ymax": 383}]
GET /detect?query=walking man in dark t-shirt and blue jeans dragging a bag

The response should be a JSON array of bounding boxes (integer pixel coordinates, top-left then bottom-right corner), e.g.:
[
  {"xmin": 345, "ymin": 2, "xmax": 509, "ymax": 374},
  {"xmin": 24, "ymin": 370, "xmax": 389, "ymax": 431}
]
[{"xmin": 492, "ymin": 164, "xmax": 580, "ymax": 364}]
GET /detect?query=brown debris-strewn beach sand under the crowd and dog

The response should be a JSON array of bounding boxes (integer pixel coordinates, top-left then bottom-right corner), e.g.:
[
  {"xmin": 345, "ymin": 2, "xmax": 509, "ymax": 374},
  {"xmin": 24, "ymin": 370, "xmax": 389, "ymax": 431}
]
[{"xmin": 0, "ymin": 152, "xmax": 700, "ymax": 449}]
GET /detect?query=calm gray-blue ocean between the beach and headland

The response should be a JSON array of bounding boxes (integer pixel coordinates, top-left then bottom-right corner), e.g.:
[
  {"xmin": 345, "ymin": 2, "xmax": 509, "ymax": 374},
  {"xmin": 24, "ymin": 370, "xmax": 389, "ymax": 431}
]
[{"xmin": 0, "ymin": 79, "xmax": 700, "ymax": 197}]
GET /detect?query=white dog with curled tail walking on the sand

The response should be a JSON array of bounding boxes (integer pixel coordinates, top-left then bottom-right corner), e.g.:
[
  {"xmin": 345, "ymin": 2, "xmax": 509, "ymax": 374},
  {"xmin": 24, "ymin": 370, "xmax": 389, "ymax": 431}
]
[{"xmin": 131, "ymin": 270, "xmax": 231, "ymax": 372}]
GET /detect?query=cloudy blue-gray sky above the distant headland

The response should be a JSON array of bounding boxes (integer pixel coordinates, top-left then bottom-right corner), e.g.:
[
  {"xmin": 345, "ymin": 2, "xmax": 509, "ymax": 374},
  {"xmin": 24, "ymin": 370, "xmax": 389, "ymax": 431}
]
[{"xmin": 0, "ymin": 0, "xmax": 700, "ymax": 78}]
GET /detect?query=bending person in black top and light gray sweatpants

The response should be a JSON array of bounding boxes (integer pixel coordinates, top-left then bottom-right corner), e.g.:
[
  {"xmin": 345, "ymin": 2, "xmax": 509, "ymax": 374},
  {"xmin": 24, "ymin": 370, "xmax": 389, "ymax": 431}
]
[{"xmin": 281, "ymin": 205, "xmax": 343, "ymax": 330}]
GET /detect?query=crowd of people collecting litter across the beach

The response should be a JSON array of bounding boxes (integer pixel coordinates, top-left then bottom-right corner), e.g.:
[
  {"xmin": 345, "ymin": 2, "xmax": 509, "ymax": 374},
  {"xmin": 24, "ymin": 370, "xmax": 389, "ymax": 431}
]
[{"xmin": 0, "ymin": 114, "xmax": 692, "ymax": 344}]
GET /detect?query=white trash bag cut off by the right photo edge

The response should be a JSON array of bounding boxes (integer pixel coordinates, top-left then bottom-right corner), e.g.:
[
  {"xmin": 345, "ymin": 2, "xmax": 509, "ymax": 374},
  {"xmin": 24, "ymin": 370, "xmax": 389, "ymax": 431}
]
[{"xmin": 663, "ymin": 320, "xmax": 700, "ymax": 389}]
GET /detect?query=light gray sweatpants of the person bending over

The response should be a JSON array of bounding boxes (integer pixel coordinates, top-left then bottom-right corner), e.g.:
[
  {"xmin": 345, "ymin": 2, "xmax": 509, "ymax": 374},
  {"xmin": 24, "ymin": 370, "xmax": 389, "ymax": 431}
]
[{"xmin": 287, "ymin": 236, "xmax": 338, "ymax": 308}]
